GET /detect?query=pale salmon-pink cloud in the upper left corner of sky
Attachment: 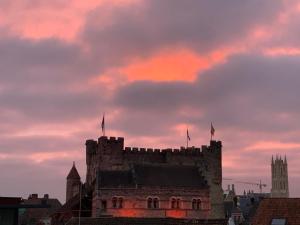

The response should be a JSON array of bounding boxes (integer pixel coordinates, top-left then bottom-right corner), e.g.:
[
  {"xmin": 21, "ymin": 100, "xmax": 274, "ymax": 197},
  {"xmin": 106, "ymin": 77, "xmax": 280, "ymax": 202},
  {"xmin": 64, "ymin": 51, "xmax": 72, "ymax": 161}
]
[{"xmin": 0, "ymin": 0, "xmax": 137, "ymax": 40}]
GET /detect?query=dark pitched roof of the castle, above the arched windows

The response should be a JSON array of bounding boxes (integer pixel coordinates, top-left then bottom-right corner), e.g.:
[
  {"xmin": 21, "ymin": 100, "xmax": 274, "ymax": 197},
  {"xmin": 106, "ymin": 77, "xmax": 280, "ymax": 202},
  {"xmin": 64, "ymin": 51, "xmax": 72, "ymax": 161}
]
[{"xmin": 98, "ymin": 165, "xmax": 208, "ymax": 188}]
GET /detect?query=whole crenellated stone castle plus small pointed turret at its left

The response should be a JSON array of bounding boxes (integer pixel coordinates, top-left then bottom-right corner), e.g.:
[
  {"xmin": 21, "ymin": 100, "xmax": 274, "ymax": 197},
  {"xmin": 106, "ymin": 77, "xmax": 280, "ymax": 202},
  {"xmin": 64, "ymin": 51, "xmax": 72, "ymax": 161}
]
[{"xmin": 66, "ymin": 136, "xmax": 224, "ymax": 219}]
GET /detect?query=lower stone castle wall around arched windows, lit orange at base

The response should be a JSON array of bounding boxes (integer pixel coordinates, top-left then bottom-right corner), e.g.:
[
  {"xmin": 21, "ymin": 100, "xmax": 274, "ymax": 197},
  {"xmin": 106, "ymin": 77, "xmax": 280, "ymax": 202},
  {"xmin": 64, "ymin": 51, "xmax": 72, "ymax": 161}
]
[{"xmin": 93, "ymin": 188, "xmax": 211, "ymax": 219}]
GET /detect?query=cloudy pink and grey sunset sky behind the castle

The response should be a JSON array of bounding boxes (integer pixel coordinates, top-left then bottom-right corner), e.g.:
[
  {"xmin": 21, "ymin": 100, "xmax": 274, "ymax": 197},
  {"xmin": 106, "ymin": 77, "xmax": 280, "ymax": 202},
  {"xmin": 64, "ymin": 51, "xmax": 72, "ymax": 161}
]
[{"xmin": 0, "ymin": 0, "xmax": 300, "ymax": 202}]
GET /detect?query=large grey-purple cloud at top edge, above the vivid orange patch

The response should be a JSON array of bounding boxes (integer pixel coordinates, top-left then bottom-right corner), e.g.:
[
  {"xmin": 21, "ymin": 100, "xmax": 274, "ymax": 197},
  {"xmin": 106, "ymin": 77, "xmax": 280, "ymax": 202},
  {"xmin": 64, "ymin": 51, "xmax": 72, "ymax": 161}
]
[{"xmin": 81, "ymin": 0, "xmax": 282, "ymax": 67}]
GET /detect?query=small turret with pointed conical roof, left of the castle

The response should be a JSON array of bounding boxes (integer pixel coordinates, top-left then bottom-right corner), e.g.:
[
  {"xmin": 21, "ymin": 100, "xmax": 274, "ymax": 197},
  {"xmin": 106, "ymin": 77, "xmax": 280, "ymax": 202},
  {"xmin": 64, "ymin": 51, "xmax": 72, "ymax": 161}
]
[{"xmin": 66, "ymin": 162, "xmax": 81, "ymax": 202}]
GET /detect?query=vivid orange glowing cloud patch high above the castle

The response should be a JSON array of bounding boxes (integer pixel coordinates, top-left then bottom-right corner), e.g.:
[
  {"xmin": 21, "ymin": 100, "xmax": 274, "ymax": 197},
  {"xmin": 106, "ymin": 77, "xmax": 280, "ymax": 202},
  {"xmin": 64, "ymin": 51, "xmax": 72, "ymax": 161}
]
[{"xmin": 120, "ymin": 49, "xmax": 230, "ymax": 82}]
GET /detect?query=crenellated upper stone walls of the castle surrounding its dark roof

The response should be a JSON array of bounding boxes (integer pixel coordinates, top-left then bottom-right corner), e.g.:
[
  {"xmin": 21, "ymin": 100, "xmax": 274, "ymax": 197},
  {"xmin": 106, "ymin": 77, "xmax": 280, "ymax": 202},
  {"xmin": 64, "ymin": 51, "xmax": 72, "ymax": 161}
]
[{"xmin": 85, "ymin": 136, "xmax": 224, "ymax": 219}]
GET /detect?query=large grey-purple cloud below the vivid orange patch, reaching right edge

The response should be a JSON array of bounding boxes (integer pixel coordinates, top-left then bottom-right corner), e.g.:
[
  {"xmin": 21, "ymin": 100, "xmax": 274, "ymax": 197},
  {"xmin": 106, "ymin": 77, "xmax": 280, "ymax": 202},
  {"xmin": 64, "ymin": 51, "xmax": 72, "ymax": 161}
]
[{"xmin": 115, "ymin": 55, "xmax": 300, "ymax": 135}]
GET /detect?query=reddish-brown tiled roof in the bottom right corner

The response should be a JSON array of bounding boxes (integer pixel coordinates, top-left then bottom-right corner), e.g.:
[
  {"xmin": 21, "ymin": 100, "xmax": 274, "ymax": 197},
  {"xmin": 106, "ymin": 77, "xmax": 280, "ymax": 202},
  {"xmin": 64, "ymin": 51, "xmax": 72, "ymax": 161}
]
[{"xmin": 252, "ymin": 198, "xmax": 300, "ymax": 225}]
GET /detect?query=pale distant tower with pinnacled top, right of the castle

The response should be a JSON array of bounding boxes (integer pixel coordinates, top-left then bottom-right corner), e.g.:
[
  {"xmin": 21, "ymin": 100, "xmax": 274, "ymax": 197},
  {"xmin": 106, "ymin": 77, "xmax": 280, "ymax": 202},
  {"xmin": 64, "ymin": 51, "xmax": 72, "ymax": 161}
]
[{"xmin": 271, "ymin": 156, "xmax": 289, "ymax": 198}]
